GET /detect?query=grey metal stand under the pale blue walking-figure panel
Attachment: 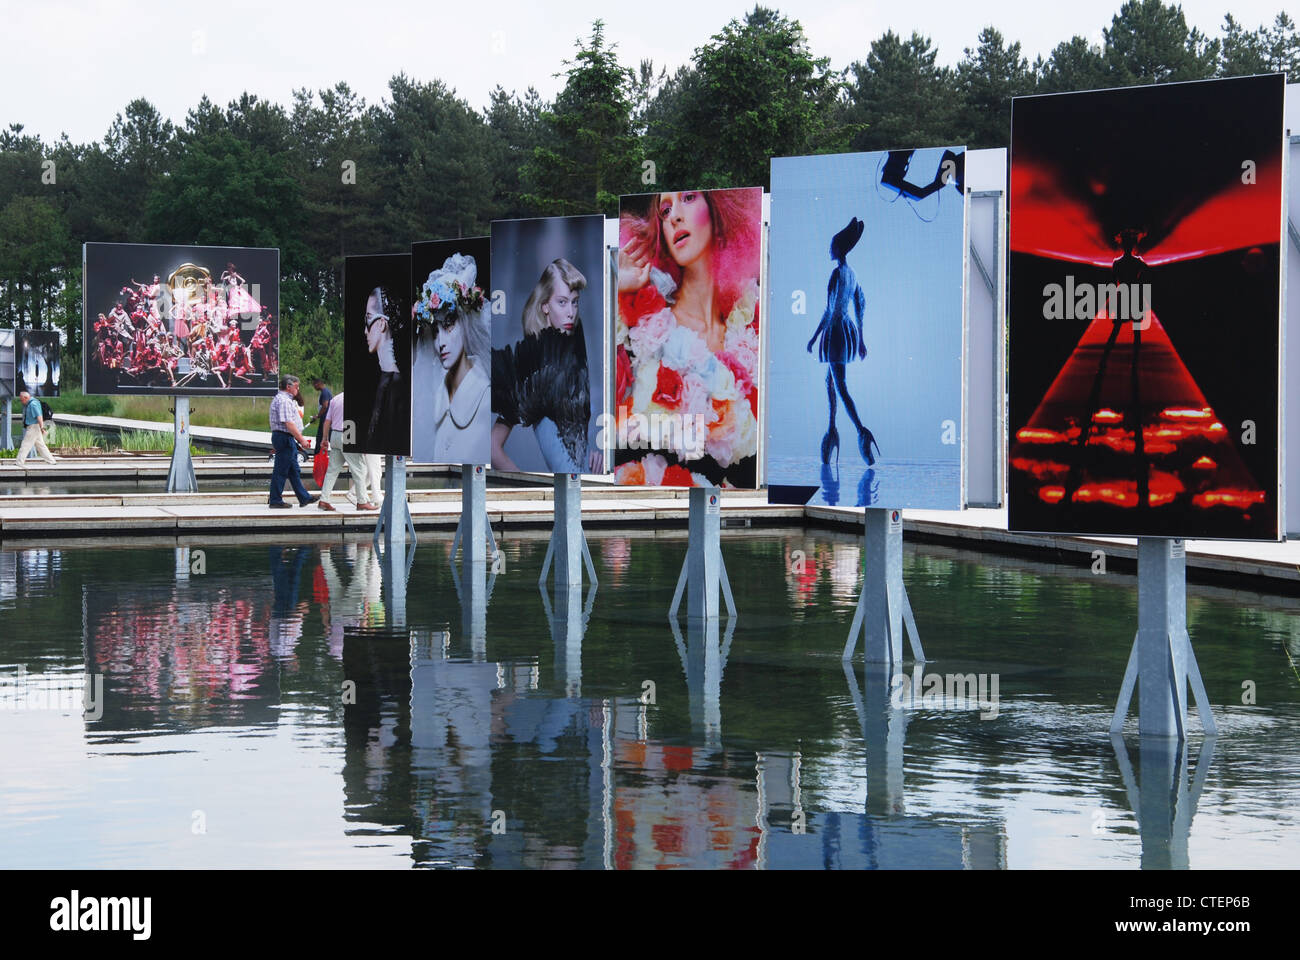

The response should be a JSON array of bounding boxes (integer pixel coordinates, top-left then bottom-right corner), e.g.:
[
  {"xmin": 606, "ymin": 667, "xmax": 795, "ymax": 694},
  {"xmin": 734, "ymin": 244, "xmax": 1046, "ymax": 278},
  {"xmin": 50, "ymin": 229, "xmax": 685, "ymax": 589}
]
[{"xmin": 844, "ymin": 509, "xmax": 926, "ymax": 665}]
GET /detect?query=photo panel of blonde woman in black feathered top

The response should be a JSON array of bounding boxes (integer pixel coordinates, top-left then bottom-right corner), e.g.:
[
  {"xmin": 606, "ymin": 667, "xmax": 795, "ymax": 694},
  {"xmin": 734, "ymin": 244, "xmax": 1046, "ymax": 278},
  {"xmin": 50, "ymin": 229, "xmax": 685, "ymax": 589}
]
[{"xmin": 491, "ymin": 213, "xmax": 608, "ymax": 473}]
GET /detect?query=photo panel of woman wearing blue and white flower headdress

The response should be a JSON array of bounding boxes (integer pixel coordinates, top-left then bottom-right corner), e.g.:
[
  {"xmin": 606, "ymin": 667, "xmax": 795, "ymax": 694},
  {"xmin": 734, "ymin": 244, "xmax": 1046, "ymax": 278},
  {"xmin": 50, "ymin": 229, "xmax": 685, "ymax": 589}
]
[{"xmin": 411, "ymin": 237, "xmax": 493, "ymax": 466}]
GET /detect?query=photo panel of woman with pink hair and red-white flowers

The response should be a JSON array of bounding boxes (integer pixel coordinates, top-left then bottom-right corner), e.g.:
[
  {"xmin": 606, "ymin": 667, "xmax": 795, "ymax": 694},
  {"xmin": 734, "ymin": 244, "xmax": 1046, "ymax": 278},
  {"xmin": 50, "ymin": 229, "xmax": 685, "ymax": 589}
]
[{"xmin": 611, "ymin": 187, "xmax": 763, "ymax": 489}]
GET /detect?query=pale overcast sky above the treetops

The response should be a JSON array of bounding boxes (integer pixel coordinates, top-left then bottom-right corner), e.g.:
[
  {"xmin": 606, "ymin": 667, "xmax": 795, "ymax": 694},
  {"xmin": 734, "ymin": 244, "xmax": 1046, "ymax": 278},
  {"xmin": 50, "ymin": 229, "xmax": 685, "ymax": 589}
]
[{"xmin": 0, "ymin": 0, "xmax": 1283, "ymax": 142}]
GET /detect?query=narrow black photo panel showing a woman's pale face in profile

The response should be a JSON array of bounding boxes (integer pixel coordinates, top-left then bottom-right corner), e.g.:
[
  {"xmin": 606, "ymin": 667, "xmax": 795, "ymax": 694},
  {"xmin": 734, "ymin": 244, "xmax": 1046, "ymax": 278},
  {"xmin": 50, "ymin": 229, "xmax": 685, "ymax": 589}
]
[{"xmin": 343, "ymin": 254, "xmax": 412, "ymax": 457}]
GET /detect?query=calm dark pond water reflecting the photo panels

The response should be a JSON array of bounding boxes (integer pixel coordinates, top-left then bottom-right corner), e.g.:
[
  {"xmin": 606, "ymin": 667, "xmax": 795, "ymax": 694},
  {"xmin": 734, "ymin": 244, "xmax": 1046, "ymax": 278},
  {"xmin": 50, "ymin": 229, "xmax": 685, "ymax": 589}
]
[{"xmin": 0, "ymin": 528, "xmax": 1300, "ymax": 869}]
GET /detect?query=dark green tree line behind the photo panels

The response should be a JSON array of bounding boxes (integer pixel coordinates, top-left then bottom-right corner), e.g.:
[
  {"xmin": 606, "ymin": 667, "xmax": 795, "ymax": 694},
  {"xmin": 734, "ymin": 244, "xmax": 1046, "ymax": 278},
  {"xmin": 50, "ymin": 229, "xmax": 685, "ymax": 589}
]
[{"xmin": 0, "ymin": 0, "xmax": 1300, "ymax": 384}]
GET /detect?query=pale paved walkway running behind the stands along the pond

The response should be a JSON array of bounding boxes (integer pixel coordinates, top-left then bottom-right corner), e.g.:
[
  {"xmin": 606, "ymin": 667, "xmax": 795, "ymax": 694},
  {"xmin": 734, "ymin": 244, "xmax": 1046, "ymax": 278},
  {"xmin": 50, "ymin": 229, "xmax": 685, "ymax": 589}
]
[{"xmin": 0, "ymin": 457, "xmax": 1300, "ymax": 592}]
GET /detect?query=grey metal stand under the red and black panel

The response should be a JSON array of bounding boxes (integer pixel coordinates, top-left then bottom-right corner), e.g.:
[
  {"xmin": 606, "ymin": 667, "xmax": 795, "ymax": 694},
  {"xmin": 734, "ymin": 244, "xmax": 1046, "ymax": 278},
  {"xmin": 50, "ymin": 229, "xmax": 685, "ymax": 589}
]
[{"xmin": 1110, "ymin": 537, "xmax": 1218, "ymax": 740}]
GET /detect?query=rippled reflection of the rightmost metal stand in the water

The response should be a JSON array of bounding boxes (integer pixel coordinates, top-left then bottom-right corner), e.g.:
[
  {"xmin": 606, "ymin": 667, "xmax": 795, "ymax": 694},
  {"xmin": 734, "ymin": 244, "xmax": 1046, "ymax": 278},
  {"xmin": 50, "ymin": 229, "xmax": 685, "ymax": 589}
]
[{"xmin": 1110, "ymin": 734, "xmax": 1216, "ymax": 870}]
